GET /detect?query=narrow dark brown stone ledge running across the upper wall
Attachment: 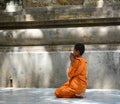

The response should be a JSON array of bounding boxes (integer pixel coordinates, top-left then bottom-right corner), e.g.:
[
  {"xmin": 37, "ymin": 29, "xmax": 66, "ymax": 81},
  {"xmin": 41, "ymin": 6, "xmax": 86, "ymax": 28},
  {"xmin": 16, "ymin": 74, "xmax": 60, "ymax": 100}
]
[{"xmin": 0, "ymin": 18, "xmax": 120, "ymax": 30}]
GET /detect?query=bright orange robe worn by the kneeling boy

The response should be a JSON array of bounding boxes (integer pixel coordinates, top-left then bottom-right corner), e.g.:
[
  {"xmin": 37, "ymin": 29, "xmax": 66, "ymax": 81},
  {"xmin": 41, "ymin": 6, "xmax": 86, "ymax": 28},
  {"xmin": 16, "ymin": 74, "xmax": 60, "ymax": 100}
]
[{"xmin": 55, "ymin": 57, "xmax": 87, "ymax": 98}]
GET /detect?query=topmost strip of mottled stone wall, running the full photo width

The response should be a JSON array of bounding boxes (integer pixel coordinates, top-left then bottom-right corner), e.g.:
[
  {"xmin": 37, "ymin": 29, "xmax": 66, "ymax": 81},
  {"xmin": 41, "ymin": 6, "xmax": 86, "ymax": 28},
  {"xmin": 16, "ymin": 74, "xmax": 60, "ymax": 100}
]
[{"xmin": 0, "ymin": 0, "xmax": 120, "ymax": 9}]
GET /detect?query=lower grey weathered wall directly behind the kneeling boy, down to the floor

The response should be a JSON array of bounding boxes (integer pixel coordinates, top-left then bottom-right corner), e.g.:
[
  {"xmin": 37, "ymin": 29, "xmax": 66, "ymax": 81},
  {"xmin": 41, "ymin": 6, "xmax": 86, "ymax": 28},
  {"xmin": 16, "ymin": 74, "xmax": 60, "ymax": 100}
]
[{"xmin": 0, "ymin": 45, "xmax": 120, "ymax": 89}]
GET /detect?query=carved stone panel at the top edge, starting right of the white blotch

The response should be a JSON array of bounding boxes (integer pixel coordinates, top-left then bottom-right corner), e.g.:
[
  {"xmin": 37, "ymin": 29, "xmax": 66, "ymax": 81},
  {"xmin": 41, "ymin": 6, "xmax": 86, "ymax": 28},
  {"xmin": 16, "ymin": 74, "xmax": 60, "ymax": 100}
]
[{"xmin": 23, "ymin": 0, "xmax": 120, "ymax": 8}]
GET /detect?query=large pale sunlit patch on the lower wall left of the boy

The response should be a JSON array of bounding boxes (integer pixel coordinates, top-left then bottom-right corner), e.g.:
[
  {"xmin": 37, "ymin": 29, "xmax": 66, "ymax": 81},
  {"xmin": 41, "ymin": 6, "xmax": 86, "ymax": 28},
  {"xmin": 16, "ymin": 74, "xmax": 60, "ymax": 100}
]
[{"xmin": 1, "ymin": 48, "xmax": 52, "ymax": 87}]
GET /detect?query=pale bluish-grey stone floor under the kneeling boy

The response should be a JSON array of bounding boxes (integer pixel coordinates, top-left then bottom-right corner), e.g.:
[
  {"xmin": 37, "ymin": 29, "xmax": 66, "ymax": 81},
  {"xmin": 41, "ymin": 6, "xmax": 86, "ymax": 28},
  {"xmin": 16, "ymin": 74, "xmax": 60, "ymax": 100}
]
[{"xmin": 0, "ymin": 88, "xmax": 120, "ymax": 104}]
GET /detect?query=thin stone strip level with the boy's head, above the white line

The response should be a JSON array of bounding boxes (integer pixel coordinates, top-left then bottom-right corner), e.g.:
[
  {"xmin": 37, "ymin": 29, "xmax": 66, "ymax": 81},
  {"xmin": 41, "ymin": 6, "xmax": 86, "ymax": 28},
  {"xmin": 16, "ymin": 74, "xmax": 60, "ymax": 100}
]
[{"xmin": 0, "ymin": 44, "xmax": 120, "ymax": 52}]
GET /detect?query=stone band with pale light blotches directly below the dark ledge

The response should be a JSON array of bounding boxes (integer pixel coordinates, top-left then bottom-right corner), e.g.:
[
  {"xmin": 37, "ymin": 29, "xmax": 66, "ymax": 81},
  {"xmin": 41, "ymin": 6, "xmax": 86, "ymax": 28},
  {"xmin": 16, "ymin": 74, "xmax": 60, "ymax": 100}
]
[{"xmin": 0, "ymin": 26, "xmax": 120, "ymax": 45}]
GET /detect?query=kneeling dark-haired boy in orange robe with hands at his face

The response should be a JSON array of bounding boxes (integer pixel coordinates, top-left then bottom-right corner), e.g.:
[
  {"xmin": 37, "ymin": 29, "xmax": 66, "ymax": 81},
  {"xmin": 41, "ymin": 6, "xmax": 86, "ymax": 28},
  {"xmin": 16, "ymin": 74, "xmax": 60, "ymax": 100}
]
[{"xmin": 55, "ymin": 43, "xmax": 87, "ymax": 98}]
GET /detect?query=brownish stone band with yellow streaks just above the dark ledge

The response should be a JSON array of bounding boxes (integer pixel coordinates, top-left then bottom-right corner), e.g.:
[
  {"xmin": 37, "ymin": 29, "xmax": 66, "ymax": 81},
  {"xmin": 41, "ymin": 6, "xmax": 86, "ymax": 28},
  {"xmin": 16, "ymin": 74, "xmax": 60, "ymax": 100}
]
[{"xmin": 0, "ymin": 0, "xmax": 120, "ymax": 22}]
